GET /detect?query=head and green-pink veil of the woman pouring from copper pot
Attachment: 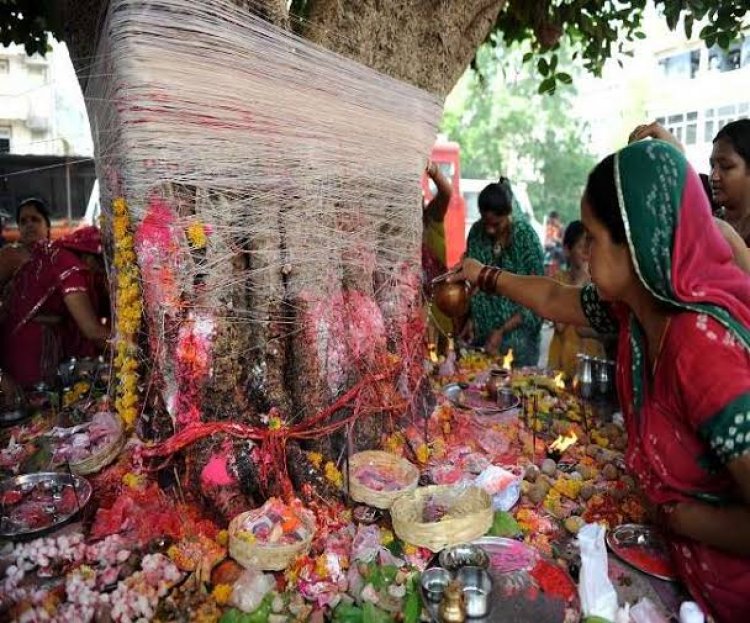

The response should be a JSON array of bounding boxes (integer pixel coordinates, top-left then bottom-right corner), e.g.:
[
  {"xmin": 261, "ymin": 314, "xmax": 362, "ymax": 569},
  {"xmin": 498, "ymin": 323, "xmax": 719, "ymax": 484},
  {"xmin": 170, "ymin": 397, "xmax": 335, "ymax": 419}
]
[{"xmin": 581, "ymin": 141, "xmax": 750, "ymax": 342}]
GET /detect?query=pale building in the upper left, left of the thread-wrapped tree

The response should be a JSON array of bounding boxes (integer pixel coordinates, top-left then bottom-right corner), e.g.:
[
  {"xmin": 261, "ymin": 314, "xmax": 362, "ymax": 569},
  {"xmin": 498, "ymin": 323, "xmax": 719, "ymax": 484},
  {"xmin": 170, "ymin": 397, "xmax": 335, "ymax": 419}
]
[{"xmin": 0, "ymin": 41, "xmax": 93, "ymax": 156}]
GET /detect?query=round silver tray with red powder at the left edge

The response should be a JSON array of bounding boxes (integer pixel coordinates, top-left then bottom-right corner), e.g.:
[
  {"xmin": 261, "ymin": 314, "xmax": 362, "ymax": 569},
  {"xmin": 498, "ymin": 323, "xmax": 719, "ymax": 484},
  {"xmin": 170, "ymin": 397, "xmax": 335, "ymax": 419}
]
[{"xmin": 0, "ymin": 472, "xmax": 92, "ymax": 539}]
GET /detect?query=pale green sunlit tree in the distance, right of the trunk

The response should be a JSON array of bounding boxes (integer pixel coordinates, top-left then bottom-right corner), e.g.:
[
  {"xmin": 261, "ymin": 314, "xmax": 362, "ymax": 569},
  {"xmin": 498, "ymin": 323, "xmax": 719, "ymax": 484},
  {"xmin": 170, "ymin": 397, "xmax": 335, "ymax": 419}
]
[{"xmin": 442, "ymin": 41, "xmax": 596, "ymax": 221}]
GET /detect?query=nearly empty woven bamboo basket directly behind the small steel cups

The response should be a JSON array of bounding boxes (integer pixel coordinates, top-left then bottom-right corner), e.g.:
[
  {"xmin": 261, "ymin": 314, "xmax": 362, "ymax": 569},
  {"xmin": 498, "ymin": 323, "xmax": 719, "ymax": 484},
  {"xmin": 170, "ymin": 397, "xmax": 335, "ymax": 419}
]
[{"xmin": 391, "ymin": 485, "xmax": 493, "ymax": 552}]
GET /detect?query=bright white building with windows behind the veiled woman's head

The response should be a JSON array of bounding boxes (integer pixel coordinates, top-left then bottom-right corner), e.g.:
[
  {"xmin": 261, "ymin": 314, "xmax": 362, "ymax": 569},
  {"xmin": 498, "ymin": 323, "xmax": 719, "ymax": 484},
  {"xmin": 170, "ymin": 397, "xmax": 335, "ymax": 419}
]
[{"xmin": 575, "ymin": 8, "xmax": 750, "ymax": 172}]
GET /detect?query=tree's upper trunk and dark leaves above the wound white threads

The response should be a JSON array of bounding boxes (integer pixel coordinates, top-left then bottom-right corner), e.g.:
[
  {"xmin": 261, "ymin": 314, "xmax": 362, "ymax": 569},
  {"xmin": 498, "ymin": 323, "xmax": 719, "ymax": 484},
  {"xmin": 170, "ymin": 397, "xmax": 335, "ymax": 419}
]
[{"xmin": 0, "ymin": 0, "xmax": 748, "ymax": 95}]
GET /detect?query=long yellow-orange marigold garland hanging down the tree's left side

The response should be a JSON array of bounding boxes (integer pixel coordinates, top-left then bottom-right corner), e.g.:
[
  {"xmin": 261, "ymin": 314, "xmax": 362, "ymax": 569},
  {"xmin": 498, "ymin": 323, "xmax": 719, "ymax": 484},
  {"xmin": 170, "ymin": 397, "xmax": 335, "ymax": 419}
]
[{"xmin": 112, "ymin": 197, "xmax": 143, "ymax": 428}]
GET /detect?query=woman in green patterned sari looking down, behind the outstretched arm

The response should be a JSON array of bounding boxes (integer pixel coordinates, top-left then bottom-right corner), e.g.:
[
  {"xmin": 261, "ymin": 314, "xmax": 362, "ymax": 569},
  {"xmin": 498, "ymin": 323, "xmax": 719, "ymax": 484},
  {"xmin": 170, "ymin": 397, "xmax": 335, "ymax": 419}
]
[{"xmin": 463, "ymin": 178, "xmax": 544, "ymax": 366}]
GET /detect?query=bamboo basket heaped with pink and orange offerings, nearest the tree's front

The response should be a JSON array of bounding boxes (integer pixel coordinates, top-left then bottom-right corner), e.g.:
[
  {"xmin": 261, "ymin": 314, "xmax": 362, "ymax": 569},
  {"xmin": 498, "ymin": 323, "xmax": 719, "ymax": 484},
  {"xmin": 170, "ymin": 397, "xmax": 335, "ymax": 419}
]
[{"xmin": 228, "ymin": 507, "xmax": 315, "ymax": 571}]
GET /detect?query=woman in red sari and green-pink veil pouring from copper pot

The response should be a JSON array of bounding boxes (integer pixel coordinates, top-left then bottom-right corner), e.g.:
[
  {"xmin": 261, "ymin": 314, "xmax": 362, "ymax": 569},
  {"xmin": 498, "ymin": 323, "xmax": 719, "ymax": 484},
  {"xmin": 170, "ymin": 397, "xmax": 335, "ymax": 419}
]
[{"xmin": 456, "ymin": 141, "xmax": 750, "ymax": 622}]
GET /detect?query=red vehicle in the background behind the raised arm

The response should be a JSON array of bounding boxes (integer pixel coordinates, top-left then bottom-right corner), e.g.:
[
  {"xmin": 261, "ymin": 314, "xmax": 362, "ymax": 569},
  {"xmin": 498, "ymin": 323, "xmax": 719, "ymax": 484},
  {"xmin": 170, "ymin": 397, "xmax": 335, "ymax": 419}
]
[{"xmin": 422, "ymin": 140, "xmax": 466, "ymax": 267}]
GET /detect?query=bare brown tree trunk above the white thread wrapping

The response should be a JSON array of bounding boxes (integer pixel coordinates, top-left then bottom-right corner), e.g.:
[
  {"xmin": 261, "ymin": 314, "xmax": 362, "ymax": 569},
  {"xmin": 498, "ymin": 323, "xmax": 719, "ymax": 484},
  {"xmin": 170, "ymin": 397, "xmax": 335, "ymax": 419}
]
[{"xmin": 63, "ymin": 0, "xmax": 506, "ymax": 96}]
